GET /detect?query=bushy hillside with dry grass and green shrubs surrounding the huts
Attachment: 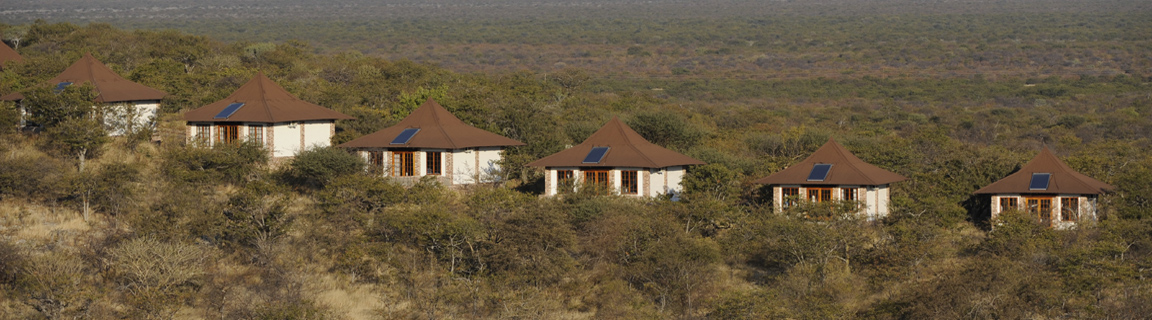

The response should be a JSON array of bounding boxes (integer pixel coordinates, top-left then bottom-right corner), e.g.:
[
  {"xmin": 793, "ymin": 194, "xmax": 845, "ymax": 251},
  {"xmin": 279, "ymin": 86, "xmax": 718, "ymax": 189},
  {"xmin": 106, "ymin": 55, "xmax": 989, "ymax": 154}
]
[{"xmin": 0, "ymin": 23, "xmax": 1152, "ymax": 319}]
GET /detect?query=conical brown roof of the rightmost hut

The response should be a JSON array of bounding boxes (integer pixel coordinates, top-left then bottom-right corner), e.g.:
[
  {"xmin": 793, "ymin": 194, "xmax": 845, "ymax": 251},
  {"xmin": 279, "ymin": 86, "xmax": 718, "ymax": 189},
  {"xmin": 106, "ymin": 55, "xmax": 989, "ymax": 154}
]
[{"xmin": 972, "ymin": 146, "xmax": 1116, "ymax": 195}]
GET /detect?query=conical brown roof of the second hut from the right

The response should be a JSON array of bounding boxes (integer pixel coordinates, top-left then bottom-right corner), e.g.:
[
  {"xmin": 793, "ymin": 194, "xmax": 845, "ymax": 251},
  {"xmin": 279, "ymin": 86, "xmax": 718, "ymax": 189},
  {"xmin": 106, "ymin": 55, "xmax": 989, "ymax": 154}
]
[{"xmin": 756, "ymin": 138, "xmax": 908, "ymax": 185}]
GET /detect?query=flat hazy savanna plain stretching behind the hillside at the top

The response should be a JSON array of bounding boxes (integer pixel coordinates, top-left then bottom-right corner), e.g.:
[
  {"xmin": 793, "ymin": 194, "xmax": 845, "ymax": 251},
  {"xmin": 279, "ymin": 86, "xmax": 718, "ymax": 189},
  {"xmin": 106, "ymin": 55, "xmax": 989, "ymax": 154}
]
[{"xmin": 0, "ymin": 0, "xmax": 1152, "ymax": 85}]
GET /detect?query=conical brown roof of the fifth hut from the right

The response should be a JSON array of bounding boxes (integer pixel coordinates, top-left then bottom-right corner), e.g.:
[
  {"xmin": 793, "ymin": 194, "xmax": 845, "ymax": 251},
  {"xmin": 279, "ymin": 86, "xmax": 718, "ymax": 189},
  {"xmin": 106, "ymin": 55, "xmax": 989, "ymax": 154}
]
[{"xmin": 184, "ymin": 73, "xmax": 354, "ymax": 123}]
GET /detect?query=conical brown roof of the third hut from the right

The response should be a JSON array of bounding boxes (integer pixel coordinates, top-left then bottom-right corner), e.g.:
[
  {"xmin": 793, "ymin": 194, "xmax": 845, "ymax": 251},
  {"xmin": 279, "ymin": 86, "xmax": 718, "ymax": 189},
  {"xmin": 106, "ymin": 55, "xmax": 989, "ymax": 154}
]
[{"xmin": 528, "ymin": 117, "xmax": 704, "ymax": 168}]
